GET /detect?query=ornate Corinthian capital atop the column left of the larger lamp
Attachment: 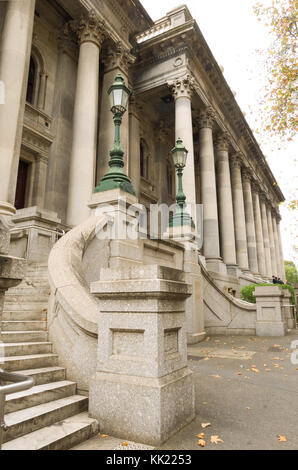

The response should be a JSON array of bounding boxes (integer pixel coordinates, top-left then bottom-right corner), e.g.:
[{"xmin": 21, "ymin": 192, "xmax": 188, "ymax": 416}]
[{"xmin": 70, "ymin": 10, "xmax": 107, "ymax": 48}]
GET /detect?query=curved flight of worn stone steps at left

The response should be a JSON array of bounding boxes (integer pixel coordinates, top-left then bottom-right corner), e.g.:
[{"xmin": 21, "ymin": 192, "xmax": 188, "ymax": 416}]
[{"xmin": 0, "ymin": 264, "xmax": 98, "ymax": 450}]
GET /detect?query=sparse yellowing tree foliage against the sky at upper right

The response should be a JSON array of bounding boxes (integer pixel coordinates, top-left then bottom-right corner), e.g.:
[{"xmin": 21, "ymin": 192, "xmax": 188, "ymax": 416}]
[{"xmin": 254, "ymin": 0, "xmax": 298, "ymax": 140}]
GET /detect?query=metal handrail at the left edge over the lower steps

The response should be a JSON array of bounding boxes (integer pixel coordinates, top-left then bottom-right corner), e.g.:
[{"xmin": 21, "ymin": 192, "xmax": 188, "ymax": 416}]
[{"xmin": 0, "ymin": 369, "xmax": 34, "ymax": 450}]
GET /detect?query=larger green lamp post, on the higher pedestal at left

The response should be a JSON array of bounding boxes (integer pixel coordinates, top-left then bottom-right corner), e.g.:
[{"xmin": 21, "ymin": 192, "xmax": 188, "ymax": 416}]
[{"xmin": 94, "ymin": 74, "xmax": 136, "ymax": 196}]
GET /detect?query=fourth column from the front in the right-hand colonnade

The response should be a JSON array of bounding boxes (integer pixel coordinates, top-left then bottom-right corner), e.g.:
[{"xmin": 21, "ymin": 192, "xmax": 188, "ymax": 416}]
[{"xmin": 231, "ymin": 154, "xmax": 249, "ymax": 272}]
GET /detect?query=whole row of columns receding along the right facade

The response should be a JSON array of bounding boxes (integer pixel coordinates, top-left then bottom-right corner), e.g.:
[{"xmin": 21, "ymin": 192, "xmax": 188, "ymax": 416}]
[{"xmin": 169, "ymin": 75, "xmax": 285, "ymax": 279}]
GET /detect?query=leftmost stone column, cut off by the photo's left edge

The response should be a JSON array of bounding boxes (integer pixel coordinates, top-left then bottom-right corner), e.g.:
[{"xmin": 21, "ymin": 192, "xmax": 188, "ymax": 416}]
[{"xmin": 0, "ymin": 0, "xmax": 35, "ymax": 216}]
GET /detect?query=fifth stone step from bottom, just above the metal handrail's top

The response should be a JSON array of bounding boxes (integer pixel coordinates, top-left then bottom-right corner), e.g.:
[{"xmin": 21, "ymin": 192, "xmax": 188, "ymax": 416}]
[{"xmin": 1, "ymin": 354, "xmax": 58, "ymax": 372}]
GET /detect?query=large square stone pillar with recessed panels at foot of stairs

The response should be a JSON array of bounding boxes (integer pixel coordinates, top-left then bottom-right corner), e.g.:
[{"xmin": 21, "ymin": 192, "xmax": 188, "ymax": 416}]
[{"xmin": 89, "ymin": 266, "xmax": 195, "ymax": 445}]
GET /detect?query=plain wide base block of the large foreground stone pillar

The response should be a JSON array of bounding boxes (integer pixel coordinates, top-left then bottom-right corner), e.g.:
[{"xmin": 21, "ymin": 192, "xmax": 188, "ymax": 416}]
[{"xmin": 89, "ymin": 367, "xmax": 195, "ymax": 446}]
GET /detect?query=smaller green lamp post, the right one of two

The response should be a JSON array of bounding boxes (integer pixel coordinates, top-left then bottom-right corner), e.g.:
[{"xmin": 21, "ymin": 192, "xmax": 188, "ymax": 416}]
[{"xmin": 170, "ymin": 138, "xmax": 195, "ymax": 228}]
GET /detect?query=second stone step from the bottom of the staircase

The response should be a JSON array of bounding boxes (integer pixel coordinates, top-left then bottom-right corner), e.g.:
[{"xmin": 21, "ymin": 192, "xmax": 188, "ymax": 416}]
[{"xmin": 3, "ymin": 395, "xmax": 88, "ymax": 442}]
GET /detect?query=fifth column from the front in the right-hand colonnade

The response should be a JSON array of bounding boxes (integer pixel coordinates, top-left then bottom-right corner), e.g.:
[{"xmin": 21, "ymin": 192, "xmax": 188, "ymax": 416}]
[{"xmin": 242, "ymin": 170, "xmax": 259, "ymax": 274}]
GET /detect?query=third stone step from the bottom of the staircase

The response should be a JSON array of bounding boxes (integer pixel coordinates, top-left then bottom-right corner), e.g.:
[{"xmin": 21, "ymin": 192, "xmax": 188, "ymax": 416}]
[{"xmin": 5, "ymin": 380, "xmax": 77, "ymax": 413}]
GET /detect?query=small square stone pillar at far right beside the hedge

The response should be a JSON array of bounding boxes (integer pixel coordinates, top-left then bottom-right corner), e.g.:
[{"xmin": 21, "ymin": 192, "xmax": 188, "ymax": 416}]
[{"xmin": 254, "ymin": 286, "xmax": 288, "ymax": 336}]
